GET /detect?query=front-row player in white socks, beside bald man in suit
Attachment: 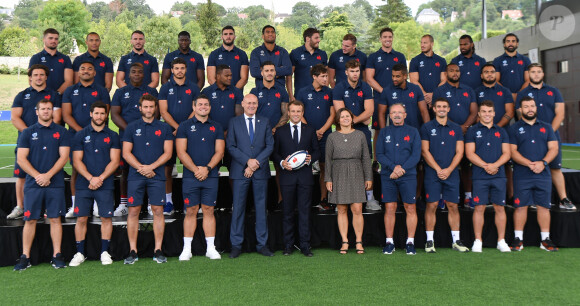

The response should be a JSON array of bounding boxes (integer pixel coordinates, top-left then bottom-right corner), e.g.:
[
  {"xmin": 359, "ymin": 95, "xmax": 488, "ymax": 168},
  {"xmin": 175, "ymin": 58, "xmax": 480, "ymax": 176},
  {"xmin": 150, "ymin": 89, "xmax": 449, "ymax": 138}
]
[{"xmin": 175, "ymin": 95, "xmax": 226, "ymax": 261}]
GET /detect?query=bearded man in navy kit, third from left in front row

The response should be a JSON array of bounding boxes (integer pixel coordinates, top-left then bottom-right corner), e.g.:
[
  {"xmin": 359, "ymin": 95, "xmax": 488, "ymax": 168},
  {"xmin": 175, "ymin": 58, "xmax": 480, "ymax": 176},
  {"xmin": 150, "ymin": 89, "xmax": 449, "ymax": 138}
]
[{"xmin": 123, "ymin": 94, "xmax": 174, "ymax": 264}]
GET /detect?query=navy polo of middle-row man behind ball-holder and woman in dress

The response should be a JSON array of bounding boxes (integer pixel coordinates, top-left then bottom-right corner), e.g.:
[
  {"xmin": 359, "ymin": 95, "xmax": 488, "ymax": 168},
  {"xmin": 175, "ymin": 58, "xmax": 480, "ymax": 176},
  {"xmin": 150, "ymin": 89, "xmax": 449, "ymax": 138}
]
[{"xmin": 296, "ymin": 84, "xmax": 334, "ymax": 134}]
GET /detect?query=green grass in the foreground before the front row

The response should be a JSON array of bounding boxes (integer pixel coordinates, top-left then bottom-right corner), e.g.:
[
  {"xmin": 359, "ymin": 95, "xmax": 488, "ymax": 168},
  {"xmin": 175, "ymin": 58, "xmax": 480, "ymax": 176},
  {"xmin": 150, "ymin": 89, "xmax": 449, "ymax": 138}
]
[{"xmin": 0, "ymin": 247, "xmax": 580, "ymax": 305}]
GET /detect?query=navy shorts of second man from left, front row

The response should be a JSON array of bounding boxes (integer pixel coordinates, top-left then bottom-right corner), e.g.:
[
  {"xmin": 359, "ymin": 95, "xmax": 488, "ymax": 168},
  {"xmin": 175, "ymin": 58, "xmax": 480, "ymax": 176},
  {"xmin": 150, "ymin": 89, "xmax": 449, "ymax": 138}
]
[{"xmin": 74, "ymin": 189, "xmax": 115, "ymax": 218}]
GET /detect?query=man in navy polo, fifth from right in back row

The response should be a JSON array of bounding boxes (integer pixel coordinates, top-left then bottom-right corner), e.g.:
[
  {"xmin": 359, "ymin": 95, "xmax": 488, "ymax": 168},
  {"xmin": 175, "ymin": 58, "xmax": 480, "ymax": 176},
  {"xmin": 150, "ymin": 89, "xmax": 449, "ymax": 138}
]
[{"xmin": 328, "ymin": 34, "xmax": 367, "ymax": 88}]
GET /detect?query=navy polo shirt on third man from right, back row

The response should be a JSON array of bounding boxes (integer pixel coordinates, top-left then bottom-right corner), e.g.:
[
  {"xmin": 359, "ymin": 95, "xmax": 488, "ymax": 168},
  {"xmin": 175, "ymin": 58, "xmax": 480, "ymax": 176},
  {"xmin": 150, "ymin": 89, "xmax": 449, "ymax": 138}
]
[{"xmin": 409, "ymin": 52, "xmax": 447, "ymax": 93}]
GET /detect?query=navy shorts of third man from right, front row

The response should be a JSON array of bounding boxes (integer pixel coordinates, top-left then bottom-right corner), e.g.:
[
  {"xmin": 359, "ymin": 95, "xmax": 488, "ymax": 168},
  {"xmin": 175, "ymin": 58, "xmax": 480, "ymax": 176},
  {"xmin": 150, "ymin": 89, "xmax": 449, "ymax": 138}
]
[{"xmin": 424, "ymin": 166, "xmax": 460, "ymax": 203}]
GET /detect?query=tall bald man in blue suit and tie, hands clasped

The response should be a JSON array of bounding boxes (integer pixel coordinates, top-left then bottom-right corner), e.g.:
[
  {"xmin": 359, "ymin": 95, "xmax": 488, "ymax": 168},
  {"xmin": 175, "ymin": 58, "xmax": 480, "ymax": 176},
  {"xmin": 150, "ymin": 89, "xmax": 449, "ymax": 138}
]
[{"xmin": 226, "ymin": 94, "xmax": 274, "ymax": 258}]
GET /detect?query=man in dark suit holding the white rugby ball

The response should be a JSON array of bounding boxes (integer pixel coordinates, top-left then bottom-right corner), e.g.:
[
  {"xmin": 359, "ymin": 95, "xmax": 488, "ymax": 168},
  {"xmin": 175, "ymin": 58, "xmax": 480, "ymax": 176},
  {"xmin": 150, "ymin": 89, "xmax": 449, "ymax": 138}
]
[{"xmin": 272, "ymin": 100, "xmax": 320, "ymax": 257}]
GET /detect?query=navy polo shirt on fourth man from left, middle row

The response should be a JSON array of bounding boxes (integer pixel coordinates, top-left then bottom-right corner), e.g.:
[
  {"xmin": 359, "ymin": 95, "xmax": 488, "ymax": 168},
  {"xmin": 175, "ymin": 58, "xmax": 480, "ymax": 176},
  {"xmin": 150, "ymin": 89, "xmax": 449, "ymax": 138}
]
[{"xmin": 159, "ymin": 77, "xmax": 199, "ymax": 124}]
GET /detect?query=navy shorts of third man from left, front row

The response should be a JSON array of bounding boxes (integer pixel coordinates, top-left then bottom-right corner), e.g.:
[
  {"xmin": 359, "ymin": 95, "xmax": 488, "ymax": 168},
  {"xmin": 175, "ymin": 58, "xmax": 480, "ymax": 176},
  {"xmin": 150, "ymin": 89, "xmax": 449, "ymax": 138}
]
[{"xmin": 127, "ymin": 179, "xmax": 165, "ymax": 207}]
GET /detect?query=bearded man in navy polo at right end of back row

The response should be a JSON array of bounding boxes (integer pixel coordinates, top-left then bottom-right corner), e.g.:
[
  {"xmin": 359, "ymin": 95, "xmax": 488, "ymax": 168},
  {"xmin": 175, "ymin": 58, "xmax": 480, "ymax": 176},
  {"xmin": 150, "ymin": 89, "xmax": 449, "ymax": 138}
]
[{"xmin": 493, "ymin": 33, "xmax": 532, "ymax": 100}]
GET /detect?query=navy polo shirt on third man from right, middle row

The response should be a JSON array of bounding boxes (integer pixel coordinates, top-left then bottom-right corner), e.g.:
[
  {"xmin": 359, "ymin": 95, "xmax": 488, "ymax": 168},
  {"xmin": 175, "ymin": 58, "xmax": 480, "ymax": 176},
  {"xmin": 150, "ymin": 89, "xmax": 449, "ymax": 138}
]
[{"xmin": 433, "ymin": 82, "xmax": 476, "ymax": 124}]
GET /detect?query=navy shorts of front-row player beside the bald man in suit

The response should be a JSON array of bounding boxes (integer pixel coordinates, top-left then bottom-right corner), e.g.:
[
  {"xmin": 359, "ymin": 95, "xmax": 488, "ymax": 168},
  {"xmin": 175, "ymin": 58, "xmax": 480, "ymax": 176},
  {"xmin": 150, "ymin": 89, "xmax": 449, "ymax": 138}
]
[{"xmin": 182, "ymin": 177, "xmax": 219, "ymax": 208}]
